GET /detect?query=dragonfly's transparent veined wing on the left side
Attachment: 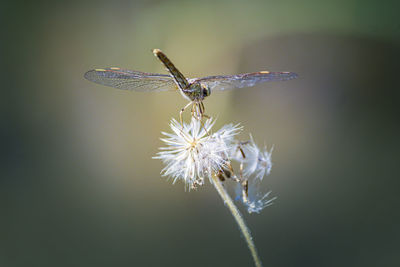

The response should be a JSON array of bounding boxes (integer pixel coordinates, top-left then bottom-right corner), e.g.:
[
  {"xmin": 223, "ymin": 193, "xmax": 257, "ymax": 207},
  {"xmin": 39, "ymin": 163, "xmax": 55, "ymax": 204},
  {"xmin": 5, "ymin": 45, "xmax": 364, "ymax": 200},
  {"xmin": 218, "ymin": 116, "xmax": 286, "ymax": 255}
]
[{"xmin": 84, "ymin": 68, "xmax": 178, "ymax": 92}]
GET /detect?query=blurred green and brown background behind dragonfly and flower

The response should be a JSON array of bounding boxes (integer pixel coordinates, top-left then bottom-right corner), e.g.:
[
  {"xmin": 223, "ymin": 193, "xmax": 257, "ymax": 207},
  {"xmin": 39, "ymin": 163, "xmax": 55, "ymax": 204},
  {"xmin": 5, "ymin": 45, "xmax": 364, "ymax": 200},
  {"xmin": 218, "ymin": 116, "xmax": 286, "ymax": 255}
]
[{"xmin": 0, "ymin": 0, "xmax": 400, "ymax": 267}]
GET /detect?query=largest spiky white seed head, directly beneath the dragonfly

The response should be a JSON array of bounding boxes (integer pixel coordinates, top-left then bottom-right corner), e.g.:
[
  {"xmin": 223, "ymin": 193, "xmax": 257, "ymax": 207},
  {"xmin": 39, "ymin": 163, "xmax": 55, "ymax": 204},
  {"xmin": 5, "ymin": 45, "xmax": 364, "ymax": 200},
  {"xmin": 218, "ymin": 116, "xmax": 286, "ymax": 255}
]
[{"xmin": 154, "ymin": 118, "xmax": 241, "ymax": 189}]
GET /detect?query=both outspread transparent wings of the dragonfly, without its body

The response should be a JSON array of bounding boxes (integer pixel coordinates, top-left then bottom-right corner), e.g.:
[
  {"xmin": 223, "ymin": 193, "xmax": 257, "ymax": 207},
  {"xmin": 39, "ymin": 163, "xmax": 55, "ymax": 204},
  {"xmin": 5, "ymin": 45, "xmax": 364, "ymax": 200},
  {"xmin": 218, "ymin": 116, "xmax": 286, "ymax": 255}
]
[{"xmin": 85, "ymin": 68, "xmax": 297, "ymax": 92}]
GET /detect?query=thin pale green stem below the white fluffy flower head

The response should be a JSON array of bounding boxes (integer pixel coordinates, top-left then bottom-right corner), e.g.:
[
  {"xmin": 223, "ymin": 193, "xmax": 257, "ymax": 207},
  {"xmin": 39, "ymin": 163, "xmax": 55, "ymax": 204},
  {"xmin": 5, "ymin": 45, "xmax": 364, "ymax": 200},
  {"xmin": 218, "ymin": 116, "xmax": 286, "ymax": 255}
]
[{"xmin": 212, "ymin": 175, "xmax": 262, "ymax": 267}]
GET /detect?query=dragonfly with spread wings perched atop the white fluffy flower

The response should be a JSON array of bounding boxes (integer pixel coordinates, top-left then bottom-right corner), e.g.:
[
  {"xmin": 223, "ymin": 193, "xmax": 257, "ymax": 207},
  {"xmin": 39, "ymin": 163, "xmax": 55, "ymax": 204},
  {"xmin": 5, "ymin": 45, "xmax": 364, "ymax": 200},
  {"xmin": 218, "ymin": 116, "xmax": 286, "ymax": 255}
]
[{"xmin": 84, "ymin": 49, "xmax": 297, "ymax": 124}]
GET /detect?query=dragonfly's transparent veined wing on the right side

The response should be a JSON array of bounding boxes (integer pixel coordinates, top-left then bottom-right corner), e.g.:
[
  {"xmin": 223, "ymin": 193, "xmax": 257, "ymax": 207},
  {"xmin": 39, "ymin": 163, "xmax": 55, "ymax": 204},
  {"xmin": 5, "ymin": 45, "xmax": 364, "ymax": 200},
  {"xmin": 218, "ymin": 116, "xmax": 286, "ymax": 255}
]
[{"xmin": 189, "ymin": 71, "xmax": 297, "ymax": 91}]
